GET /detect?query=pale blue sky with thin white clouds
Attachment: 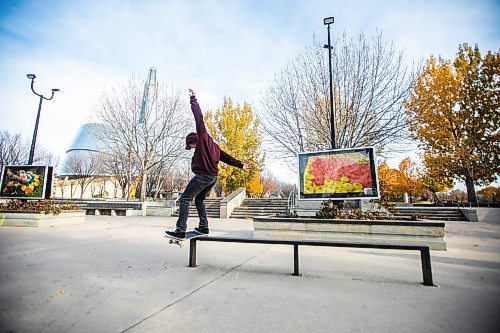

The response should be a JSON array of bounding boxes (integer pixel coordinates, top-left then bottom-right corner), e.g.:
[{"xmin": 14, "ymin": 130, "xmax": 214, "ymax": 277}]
[{"xmin": 0, "ymin": 0, "xmax": 500, "ymax": 182}]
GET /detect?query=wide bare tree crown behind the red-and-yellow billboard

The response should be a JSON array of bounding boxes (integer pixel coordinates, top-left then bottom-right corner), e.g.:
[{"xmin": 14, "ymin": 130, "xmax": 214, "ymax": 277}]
[{"xmin": 259, "ymin": 33, "xmax": 417, "ymax": 169}]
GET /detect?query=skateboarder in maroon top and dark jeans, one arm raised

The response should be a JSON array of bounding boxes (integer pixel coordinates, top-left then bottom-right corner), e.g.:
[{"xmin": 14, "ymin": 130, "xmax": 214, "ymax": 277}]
[{"xmin": 165, "ymin": 89, "xmax": 251, "ymax": 240}]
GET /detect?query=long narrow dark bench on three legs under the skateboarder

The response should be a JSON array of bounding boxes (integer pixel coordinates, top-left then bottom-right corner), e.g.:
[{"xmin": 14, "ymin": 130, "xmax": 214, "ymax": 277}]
[{"xmin": 189, "ymin": 236, "xmax": 434, "ymax": 286}]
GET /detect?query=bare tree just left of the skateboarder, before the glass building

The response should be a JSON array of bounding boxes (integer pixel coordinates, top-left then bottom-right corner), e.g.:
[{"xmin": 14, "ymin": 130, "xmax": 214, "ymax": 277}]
[{"xmin": 96, "ymin": 78, "xmax": 189, "ymax": 200}]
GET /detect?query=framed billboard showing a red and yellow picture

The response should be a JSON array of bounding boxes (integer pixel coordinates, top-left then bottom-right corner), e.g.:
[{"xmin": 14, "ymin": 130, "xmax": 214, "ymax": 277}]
[{"xmin": 298, "ymin": 147, "xmax": 380, "ymax": 200}]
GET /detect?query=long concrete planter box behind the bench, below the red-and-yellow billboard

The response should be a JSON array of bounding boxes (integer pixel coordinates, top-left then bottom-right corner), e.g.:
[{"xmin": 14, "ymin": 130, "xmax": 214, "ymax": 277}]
[{"xmin": 253, "ymin": 217, "xmax": 446, "ymax": 251}]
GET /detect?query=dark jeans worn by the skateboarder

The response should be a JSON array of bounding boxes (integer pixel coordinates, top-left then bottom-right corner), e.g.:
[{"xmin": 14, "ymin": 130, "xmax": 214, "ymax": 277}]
[{"xmin": 177, "ymin": 173, "xmax": 217, "ymax": 232}]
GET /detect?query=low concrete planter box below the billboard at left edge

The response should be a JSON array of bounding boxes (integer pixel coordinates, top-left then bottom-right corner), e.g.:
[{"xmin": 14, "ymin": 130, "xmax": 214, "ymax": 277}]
[{"xmin": 0, "ymin": 210, "xmax": 85, "ymax": 227}]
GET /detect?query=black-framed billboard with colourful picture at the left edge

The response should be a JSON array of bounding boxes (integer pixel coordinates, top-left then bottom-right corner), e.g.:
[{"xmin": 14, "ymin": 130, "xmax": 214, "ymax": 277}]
[{"xmin": 0, "ymin": 165, "xmax": 53, "ymax": 199}]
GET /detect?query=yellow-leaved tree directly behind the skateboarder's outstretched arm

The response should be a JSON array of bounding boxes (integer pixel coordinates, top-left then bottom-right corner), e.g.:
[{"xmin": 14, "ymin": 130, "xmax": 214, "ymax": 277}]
[{"xmin": 205, "ymin": 98, "xmax": 264, "ymax": 194}]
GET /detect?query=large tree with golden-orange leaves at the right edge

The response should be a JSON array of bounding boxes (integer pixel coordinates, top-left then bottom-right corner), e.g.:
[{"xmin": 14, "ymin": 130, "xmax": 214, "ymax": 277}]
[{"xmin": 406, "ymin": 44, "xmax": 500, "ymax": 202}]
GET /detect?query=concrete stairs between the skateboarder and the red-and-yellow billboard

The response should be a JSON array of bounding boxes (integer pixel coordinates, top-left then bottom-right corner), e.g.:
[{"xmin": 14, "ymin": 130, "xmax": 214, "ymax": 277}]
[{"xmin": 230, "ymin": 198, "xmax": 288, "ymax": 218}]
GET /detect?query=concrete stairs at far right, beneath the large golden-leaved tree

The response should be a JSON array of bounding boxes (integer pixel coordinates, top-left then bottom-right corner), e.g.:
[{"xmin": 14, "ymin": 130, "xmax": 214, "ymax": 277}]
[{"xmin": 393, "ymin": 206, "xmax": 467, "ymax": 221}]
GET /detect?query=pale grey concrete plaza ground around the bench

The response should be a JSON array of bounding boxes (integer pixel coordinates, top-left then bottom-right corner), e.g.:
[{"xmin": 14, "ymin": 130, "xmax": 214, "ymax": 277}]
[{"xmin": 0, "ymin": 216, "xmax": 500, "ymax": 333}]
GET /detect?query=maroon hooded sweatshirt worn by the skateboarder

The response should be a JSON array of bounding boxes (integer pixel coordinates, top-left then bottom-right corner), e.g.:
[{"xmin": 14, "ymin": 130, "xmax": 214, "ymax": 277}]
[{"xmin": 191, "ymin": 96, "xmax": 243, "ymax": 176}]
